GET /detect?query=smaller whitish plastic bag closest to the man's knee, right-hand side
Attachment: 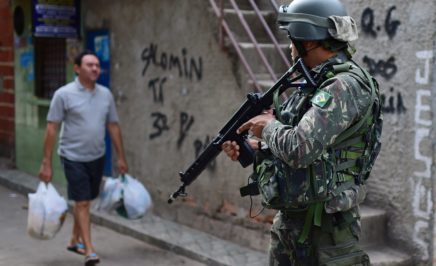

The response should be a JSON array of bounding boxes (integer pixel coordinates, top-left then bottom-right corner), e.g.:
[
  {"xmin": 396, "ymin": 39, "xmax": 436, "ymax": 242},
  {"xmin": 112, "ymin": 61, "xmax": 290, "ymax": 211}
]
[{"xmin": 94, "ymin": 177, "xmax": 123, "ymax": 211}]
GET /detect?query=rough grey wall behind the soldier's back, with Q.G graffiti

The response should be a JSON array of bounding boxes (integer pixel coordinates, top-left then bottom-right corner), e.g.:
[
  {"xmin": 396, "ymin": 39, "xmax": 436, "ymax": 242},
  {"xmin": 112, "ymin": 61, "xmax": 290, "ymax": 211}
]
[{"xmin": 346, "ymin": 0, "xmax": 435, "ymax": 262}]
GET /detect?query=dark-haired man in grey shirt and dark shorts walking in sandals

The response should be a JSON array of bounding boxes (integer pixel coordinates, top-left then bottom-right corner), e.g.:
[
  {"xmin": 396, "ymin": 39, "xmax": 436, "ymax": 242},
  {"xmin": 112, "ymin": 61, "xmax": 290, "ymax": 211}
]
[{"xmin": 39, "ymin": 51, "xmax": 128, "ymax": 266}]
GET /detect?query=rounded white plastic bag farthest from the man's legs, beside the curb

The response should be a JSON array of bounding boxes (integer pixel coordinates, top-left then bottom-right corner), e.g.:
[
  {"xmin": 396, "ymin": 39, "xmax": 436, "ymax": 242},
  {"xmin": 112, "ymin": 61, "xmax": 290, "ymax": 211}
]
[{"xmin": 116, "ymin": 174, "xmax": 152, "ymax": 219}]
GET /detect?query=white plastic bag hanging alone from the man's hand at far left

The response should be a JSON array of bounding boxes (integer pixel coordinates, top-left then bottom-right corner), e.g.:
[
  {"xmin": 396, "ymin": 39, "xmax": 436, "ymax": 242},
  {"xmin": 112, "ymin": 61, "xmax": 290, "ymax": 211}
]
[{"xmin": 27, "ymin": 182, "xmax": 68, "ymax": 239}]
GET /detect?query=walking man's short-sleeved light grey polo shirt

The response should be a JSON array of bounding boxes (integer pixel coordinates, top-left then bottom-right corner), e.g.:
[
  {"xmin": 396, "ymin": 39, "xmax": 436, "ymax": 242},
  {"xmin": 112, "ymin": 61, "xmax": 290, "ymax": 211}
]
[{"xmin": 47, "ymin": 78, "xmax": 118, "ymax": 162}]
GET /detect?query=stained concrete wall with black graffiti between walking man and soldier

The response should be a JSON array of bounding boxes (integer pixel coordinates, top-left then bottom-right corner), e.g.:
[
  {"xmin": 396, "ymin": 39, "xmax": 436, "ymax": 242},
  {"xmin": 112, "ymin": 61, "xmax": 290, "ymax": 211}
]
[{"xmin": 84, "ymin": 0, "xmax": 271, "ymax": 250}]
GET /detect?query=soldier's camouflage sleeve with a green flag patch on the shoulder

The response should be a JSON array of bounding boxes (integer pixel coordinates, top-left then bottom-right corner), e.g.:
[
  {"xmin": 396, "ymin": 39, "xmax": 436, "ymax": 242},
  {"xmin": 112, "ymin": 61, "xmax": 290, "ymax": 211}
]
[{"xmin": 262, "ymin": 77, "xmax": 371, "ymax": 168}]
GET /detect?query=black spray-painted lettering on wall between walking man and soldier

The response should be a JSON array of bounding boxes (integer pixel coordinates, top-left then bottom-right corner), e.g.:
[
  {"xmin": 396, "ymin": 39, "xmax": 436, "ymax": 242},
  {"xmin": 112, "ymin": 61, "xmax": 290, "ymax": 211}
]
[{"xmin": 140, "ymin": 43, "xmax": 215, "ymax": 170}]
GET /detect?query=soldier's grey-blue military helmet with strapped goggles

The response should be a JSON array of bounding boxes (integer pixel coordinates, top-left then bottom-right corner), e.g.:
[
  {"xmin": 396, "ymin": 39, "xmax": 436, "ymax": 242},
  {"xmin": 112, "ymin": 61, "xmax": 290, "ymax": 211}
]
[{"xmin": 278, "ymin": 0, "xmax": 350, "ymax": 41}]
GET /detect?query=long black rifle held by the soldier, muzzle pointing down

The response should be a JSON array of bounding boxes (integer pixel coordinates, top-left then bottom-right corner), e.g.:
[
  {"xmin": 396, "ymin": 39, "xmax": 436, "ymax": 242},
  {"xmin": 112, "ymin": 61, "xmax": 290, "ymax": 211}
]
[{"xmin": 168, "ymin": 59, "xmax": 316, "ymax": 203}]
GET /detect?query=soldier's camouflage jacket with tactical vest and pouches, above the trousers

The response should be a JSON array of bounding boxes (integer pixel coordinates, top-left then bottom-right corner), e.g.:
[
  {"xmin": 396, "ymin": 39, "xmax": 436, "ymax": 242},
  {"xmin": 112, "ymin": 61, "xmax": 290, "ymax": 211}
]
[{"xmin": 253, "ymin": 55, "xmax": 381, "ymax": 213}]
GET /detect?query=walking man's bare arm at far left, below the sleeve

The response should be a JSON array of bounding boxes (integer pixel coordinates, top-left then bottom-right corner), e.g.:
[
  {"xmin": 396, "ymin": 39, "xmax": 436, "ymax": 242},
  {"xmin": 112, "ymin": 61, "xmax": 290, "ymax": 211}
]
[{"xmin": 39, "ymin": 122, "xmax": 59, "ymax": 183}]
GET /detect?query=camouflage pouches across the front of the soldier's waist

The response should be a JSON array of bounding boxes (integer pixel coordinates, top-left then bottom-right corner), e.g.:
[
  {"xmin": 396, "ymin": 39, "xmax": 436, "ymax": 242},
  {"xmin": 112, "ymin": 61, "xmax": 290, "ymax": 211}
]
[{"xmin": 247, "ymin": 150, "xmax": 333, "ymax": 209}]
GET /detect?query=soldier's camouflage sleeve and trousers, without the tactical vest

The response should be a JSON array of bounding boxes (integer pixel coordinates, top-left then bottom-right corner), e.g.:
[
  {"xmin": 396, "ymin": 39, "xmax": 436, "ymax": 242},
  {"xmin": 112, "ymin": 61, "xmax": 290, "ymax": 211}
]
[{"xmin": 262, "ymin": 52, "xmax": 371, "ymax": 265}]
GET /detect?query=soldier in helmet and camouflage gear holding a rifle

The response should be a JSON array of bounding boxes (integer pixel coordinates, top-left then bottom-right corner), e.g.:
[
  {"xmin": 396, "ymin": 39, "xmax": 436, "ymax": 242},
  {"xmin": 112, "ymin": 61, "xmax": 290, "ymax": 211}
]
[{"xmin": 222, "ymin": 0, "xmax": 382, "ymax": 265}]
